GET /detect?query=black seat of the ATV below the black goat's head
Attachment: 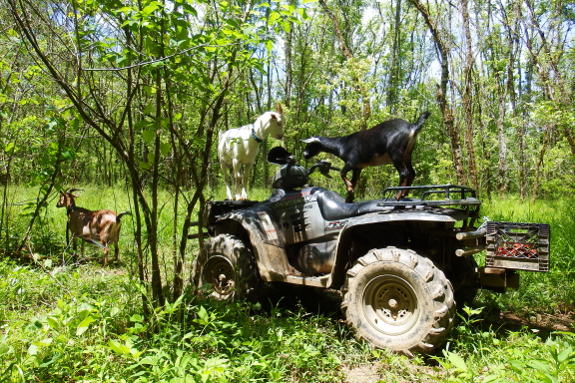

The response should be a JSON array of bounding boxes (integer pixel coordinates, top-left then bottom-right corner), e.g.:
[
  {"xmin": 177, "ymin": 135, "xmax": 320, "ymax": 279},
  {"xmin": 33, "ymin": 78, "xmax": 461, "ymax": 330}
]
[{"xmin": 314, "ymin": 189, "xmax": 385, "ymax": 221}]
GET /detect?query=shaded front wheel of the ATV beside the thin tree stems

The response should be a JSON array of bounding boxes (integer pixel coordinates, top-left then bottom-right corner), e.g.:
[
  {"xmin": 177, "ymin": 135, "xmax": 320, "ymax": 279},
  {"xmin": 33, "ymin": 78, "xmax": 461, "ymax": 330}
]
[{"xmin": 192, "ymin": 234, "xmax": 261, "ymax": 302}]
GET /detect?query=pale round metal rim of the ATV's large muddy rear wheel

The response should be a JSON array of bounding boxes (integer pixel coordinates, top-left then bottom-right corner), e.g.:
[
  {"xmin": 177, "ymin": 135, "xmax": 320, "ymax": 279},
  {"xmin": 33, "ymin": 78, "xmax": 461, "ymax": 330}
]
[{"xmin": 362, "ymin": 274, "xmax": 420, "ymax": 335}]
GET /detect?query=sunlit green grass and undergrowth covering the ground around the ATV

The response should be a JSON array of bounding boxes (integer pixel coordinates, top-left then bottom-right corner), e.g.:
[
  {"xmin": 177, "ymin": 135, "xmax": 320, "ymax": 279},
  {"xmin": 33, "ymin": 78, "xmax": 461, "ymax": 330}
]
[{"xmin": 0, "ymin": 187, "xmax": 575, "ymax": 383}]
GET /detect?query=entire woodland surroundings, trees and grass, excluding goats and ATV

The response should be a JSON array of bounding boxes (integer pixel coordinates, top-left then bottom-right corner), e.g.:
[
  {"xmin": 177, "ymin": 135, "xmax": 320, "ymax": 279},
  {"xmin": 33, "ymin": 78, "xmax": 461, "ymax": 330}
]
[{"xmin": 0, "ymin": 0, "xmax": 575, "ymax": 383}]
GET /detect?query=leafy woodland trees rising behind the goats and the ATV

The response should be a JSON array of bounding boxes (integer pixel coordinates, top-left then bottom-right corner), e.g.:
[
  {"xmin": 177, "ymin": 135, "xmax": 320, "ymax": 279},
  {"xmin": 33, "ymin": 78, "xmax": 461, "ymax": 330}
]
[{"xmin": 0, "ymin": 0, "xmax": 575, "ymax": 324}]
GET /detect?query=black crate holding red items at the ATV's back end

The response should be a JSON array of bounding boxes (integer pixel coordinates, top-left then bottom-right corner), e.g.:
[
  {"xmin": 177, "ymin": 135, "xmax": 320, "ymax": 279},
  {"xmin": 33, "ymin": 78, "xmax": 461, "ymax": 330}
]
[{"xmin": 485, "ymin": 221, "xmax": 551, "ymax": 272}]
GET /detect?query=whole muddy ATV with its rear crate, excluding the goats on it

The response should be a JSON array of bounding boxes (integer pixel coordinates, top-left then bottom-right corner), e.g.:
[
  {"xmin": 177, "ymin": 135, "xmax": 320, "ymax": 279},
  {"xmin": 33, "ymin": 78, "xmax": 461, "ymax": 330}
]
[{"xmin": 192, "ymin": 147, "xmax": 550, "ymax": 356}]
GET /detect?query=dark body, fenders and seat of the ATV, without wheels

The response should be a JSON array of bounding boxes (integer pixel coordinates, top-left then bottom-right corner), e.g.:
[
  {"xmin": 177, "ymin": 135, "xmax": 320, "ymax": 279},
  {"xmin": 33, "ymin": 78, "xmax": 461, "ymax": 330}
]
[{"xmin": 206, "ymin": 185, "xmax": 488, "ymax": 288}]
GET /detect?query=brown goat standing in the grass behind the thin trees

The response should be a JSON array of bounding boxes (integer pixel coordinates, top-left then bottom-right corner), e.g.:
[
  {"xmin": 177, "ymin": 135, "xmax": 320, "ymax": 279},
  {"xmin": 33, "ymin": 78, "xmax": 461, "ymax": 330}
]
[{"xmin": 56, "ymin": 189, "xmax": 131, "ymax": 267}]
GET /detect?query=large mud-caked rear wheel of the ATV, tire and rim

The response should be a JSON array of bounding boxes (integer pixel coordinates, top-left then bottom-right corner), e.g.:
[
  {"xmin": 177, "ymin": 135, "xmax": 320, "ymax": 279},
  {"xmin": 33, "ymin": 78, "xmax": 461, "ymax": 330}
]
[{"xmin": 342, "ymin": 247, "xmax": 455, "ymax": 356}]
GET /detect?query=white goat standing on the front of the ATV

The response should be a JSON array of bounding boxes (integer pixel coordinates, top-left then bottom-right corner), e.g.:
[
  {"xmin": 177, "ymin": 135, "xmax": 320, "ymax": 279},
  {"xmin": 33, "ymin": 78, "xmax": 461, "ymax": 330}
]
[{"xmin": 218, "ymin": 103, "xmax": 283, "ymax": 200}]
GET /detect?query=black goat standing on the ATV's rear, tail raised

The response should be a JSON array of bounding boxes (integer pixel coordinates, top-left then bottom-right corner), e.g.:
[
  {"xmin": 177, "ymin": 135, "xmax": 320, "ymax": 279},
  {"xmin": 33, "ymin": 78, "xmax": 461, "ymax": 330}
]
[{"xmin": 303, "ymin": 112, "xmax": 430, "ymax": 202}]
